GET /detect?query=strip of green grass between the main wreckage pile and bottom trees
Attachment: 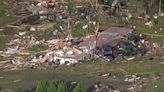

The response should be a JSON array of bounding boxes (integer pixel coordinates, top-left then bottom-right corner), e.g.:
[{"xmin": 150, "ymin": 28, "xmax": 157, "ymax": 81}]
[{"xmin": 0, "ymin": 61, "xmax": 164, "ymax": 92}]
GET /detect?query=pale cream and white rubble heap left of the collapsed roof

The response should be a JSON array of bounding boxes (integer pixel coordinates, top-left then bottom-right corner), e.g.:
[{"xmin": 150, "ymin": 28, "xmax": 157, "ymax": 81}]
[{"xmin": 25, "ymin": 47, "xmax": 85, "ymax": 65}]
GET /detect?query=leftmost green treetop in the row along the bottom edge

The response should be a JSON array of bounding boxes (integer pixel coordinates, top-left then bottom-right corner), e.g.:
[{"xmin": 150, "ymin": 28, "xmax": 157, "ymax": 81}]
[{"xmin": 36, "ymin": 80, "xmax": 48, "ymax": 92}]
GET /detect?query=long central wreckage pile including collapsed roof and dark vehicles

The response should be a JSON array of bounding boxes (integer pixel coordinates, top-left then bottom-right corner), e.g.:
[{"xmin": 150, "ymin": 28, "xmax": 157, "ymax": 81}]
[{"xmin": 0, "ymin": 27, "xmax": 152, "ymax": 69}]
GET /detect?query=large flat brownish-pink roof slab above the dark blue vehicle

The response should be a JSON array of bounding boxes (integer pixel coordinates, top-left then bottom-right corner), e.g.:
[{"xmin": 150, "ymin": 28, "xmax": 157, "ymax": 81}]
[{"xmin": 97, "ymin": 27, "xmax": 132, "ymax": 47}]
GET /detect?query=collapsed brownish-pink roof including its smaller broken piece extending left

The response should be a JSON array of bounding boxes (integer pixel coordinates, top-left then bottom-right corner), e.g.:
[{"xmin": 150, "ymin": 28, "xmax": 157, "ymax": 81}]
[{"xmin": 79, "ymin": 27, "xmax": 132, "ymax": 48}]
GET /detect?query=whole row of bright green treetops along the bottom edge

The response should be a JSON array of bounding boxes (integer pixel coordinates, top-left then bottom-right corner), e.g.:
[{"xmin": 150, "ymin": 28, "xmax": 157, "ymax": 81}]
[{"xmin": 16, "ymin": 80, "xmax": 86, "ymax": 92}]
